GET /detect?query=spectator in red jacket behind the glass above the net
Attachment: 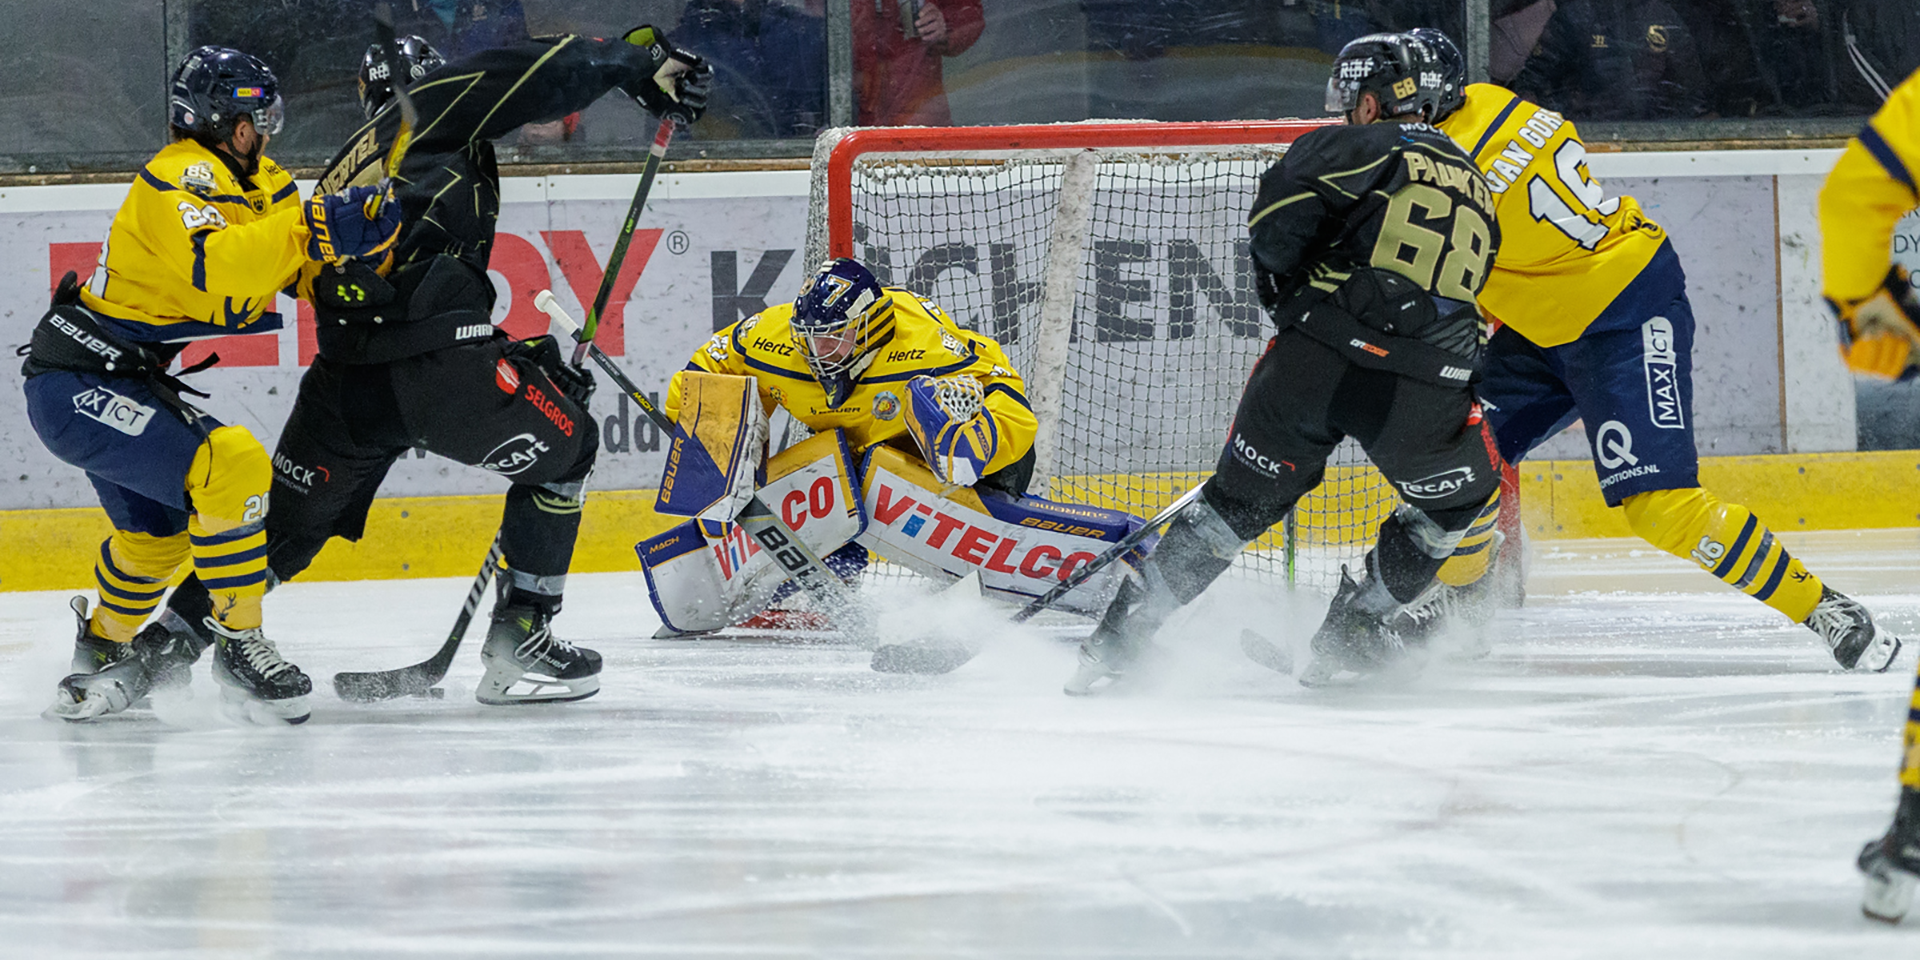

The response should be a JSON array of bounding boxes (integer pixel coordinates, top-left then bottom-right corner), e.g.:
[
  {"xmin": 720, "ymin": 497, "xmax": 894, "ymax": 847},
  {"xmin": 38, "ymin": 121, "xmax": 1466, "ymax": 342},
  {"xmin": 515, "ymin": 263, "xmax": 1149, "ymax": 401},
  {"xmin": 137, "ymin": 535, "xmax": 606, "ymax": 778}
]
[{"xmin": 851, "ymin": 0, "xmax": 987, "ymax": 127}]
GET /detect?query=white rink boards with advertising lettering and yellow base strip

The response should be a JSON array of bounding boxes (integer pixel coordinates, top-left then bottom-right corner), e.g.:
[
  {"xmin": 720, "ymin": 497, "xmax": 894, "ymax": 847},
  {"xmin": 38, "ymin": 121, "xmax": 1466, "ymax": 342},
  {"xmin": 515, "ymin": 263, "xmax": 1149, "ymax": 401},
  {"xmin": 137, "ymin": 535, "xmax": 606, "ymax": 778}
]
[{"xmin": 0, "ymin": 150, "xmax": 1920, "ymax": 589}]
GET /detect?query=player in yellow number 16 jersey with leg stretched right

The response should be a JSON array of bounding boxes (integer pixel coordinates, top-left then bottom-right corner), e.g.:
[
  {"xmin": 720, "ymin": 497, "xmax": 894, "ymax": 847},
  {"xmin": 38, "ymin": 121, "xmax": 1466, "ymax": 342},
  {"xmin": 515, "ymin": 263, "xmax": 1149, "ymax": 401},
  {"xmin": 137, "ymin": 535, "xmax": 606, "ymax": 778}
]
[{"xmin": 1409, "ymin": 29, "xmax": 1901, "ymax": 670}]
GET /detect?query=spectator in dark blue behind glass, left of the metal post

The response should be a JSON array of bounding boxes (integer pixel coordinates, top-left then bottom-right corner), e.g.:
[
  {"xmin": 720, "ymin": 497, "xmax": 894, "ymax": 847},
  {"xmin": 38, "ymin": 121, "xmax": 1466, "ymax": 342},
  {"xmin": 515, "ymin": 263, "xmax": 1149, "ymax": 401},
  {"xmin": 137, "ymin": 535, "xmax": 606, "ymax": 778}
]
[{"xmin": 674, "ymin": 0, "xmax": 825, "ymax": 138}]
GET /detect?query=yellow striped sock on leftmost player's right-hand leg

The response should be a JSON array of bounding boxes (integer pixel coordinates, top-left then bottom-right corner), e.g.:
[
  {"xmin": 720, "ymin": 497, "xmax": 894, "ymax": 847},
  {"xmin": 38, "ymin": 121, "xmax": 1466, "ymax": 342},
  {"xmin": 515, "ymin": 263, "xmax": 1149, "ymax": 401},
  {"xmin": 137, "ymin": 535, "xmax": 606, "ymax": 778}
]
[{"xmin": 186, "ymin": 426, "xmax": 273, "ymax": 630}]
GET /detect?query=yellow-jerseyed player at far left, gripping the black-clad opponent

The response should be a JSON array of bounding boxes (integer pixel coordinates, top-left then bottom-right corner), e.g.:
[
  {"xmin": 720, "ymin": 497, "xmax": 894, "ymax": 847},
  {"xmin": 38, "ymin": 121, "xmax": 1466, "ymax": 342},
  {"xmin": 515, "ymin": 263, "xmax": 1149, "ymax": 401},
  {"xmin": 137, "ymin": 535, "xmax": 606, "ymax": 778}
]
[{"xmin": 23, "ymin": 46, "xmax": 397, "ymax": 724}]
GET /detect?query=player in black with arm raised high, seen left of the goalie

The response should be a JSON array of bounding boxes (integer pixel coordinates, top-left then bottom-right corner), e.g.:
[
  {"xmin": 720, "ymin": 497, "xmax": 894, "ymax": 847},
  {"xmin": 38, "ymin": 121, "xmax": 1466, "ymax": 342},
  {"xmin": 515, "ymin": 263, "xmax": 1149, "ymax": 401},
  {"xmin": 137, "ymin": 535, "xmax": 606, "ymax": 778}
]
[{"xmin": 161, "ymin": 27, "xmax": 712, "ymax": 703}]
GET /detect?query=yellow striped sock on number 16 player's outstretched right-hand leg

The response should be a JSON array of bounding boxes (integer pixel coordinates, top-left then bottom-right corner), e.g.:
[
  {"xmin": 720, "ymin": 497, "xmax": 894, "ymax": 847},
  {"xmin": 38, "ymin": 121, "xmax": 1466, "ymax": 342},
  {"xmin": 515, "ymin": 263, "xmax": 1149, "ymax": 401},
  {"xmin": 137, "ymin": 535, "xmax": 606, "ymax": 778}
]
[{"xmin": 1620, "ymin": 488, "xmax": 1820, "ymax": 622}]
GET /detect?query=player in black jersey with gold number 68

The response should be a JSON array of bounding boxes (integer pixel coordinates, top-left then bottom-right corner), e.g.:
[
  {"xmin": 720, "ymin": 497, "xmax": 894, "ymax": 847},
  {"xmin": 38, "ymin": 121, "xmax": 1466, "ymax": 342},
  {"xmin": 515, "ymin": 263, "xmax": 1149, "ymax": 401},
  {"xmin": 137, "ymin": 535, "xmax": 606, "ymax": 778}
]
[{"xmin": 1066, "ymin": 35, "xmax": 1500, "ymax": 695}]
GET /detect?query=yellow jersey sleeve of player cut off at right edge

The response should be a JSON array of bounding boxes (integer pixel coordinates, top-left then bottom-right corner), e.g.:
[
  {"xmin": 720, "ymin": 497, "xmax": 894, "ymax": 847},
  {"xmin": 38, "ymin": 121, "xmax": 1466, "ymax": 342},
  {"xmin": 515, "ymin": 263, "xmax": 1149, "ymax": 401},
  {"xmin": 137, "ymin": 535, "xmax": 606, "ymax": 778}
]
[{"xmin": 1820, "ymin": 71, "xmax": 1920, "ymax": 303}]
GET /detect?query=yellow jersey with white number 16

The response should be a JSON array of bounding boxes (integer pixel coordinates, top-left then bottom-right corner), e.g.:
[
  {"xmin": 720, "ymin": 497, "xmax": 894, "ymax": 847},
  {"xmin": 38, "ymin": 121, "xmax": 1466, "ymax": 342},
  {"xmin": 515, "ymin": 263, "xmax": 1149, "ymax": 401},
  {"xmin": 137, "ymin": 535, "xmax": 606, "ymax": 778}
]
[{"xmin": 1436, "ymin": 83, "xmax": 1667, "ymax": 348}]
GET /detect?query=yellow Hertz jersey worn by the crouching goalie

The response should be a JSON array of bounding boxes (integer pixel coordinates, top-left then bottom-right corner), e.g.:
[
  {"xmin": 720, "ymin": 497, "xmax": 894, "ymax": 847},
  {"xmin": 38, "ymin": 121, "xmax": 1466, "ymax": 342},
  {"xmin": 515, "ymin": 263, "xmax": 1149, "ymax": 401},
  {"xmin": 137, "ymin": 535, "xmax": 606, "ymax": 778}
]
[{"xmin": 660, "ymin": 288, "xmax": 1039, "ymax": 474}]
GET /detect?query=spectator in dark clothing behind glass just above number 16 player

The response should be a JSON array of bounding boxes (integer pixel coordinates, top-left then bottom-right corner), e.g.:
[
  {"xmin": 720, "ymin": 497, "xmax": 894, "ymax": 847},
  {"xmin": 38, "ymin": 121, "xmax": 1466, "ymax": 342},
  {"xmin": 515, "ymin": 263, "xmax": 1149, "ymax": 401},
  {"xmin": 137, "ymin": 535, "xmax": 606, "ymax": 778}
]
[{"xmin": 1511, "ymin": 0, "xmax": 1709, "ymax": 121}]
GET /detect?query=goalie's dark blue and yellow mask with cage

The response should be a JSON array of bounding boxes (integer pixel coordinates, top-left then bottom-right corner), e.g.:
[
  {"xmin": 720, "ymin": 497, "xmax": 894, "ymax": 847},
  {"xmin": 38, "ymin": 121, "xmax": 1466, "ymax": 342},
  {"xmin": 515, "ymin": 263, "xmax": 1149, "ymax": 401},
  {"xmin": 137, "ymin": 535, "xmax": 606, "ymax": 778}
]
[{"xmin": 793, "ymin": 257, "xmax": 891, "ymax": 407}]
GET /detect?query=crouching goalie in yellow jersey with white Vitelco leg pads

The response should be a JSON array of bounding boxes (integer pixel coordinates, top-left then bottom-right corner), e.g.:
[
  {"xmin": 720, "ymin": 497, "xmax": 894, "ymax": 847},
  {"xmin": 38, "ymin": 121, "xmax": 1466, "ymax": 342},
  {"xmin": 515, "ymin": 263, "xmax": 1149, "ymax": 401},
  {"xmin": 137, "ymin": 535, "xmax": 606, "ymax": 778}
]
[{"xmin": 637, "ymin": 259, "xmax": 1139, "ymax": 641}]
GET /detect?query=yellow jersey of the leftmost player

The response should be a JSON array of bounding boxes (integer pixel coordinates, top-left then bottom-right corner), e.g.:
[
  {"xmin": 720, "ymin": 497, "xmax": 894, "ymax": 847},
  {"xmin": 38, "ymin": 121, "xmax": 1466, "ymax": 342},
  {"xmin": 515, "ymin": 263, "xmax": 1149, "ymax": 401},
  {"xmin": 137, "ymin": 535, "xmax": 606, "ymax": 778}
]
[{"xmin": 81, "ymin": 140, "xmax": 307, "ymax": 344}]
